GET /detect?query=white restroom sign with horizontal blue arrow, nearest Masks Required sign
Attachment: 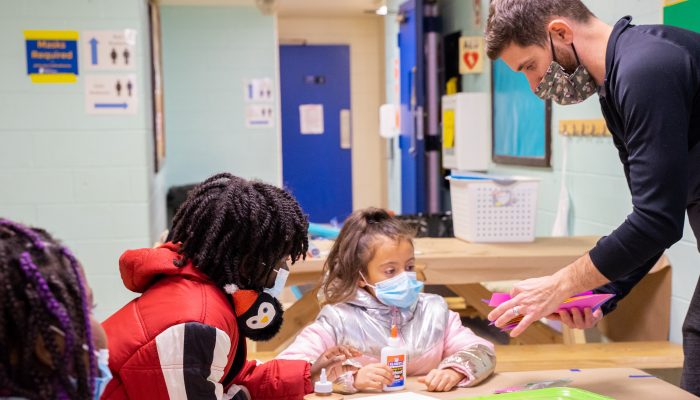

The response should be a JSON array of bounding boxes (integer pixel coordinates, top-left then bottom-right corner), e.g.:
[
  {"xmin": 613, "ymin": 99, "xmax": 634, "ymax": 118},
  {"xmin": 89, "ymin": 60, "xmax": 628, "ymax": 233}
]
[{"xmin": 85, "ymin": 74, "xmax": 138, "ymax": 115}]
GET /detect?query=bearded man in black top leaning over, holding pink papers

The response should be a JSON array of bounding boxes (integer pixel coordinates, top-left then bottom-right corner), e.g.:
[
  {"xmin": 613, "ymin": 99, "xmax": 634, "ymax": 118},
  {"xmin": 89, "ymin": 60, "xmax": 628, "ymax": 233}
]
[{"xmin": 486, "ymin": 0, "xmax": 700, "ymax": 395}]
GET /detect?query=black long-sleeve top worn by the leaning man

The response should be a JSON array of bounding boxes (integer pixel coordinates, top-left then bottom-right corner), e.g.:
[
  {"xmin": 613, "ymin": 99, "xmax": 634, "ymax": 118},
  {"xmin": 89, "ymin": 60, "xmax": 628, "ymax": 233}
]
[{"xmin": 590, "ymin": 17, "xmax": 700, "ymax": 312}]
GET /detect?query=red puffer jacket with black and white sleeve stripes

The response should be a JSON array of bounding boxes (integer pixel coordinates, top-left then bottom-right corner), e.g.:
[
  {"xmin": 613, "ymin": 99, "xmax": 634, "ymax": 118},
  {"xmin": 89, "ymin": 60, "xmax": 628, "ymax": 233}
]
[{"xmin": 102, "ymin": 243, "xmax": 312, "ymax": 400}]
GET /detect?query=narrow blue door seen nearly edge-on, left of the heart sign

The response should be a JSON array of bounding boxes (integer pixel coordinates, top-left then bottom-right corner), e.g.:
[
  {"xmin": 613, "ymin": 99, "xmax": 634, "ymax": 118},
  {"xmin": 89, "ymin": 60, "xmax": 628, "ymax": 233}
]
[{"xmin": 398, "ymin": 0, "xmax": 426, "ymax": 214}]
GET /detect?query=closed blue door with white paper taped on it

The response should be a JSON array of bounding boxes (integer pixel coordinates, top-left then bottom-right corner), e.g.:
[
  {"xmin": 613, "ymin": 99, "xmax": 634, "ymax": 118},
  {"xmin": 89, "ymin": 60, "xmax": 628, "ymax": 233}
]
[{"xmin": 280, "ymin": 45, "xmax": 352, "ymax": 223}]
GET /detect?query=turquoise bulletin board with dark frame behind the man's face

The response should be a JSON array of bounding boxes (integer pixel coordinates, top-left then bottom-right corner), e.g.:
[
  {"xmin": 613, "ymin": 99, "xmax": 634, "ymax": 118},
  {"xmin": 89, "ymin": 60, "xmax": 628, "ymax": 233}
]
[{"xmin": 491, "ymin": 60, "xmax": 552, "ymax": 167}]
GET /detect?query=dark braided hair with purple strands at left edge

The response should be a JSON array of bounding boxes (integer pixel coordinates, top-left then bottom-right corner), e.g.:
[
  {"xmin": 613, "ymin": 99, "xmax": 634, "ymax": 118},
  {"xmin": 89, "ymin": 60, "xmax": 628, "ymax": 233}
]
[{"xmin": 0, "ymin": 218, "xmax": 96, "ymax": 399}]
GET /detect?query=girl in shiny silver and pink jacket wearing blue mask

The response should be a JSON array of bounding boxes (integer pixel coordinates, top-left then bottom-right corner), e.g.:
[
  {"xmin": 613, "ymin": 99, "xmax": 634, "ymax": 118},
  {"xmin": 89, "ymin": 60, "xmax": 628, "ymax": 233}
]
[{"xmin": 278, "ymin": 208, "xmax": 495, "ymax": 393}]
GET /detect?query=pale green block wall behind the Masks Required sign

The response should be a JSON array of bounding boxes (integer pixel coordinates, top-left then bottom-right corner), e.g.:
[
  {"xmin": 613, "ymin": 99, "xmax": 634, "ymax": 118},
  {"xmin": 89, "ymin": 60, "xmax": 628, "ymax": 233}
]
[{"xmin": 0, "ymin": 0, "xmax": 165, "ymax": 319}]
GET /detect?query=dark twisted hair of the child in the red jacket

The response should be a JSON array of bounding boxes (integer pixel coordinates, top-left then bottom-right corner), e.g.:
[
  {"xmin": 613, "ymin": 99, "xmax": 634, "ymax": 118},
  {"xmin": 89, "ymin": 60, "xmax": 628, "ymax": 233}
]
[{"xmin": 169, "ymin": 173, "xmax": 309, "ymax": 290}]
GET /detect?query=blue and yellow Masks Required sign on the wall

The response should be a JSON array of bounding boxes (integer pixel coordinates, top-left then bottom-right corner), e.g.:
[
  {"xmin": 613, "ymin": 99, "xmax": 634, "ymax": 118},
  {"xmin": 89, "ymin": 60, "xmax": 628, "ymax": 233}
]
[{"xmin": 24, "ymin": 31, "xmax": 78, "ymax": 83}]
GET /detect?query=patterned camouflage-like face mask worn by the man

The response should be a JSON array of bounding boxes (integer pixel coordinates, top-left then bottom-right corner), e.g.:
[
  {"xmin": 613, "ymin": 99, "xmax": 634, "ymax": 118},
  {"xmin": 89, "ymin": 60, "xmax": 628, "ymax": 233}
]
[{"xmin": 535, "ymin": 35, "xmax": 598, "ymax": 106}]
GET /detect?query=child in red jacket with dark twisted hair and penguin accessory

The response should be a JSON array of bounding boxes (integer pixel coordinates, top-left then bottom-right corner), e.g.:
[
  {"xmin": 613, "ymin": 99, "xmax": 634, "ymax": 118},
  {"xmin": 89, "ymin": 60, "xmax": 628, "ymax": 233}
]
[{"xmin": 102, "ymin": 174, "xmax": 357, "ymax": 400}]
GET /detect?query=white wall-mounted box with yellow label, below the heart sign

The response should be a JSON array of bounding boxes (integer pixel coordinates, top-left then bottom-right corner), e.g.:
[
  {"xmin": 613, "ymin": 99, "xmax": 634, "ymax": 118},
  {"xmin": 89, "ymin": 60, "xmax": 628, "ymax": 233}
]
[{"xmin": 442, "ymin": 92, "xmax": 491, "ymax": 171}]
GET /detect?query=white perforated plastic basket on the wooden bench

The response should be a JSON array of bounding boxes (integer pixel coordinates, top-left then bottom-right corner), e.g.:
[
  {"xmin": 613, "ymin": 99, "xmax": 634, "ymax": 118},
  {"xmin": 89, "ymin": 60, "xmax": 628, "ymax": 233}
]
[{"xmin": 448, "ymin": 171, "xmax": 539, "ymax": 243}]
